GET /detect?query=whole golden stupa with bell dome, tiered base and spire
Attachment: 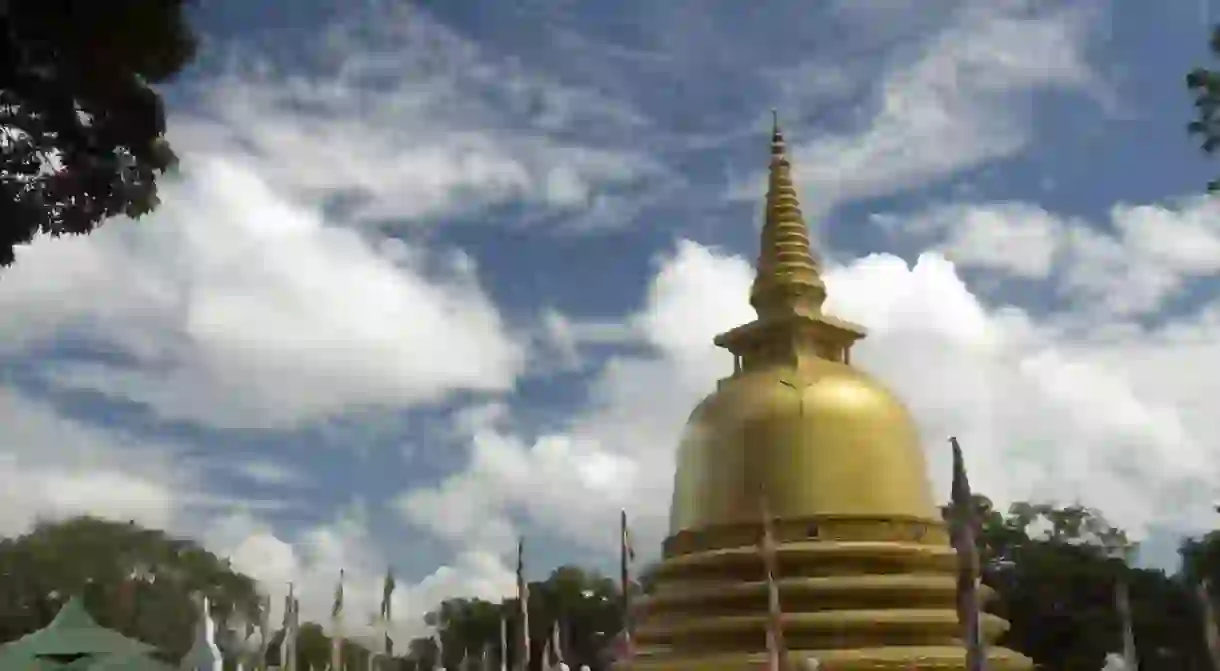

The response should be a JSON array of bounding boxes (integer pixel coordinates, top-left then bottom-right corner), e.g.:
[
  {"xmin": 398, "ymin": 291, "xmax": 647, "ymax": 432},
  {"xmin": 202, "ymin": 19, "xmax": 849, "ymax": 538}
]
[{"xmin": 630, "ymin": 117, "xmax": 1032, "ymax": 671}]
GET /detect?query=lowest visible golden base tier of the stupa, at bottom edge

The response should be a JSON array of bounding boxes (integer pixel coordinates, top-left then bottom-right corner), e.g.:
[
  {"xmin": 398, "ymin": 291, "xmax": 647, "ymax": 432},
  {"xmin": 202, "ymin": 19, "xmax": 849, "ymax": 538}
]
[{"xmin": 614, "ymin": 645, "xmax": 1033, "ymax": 671}]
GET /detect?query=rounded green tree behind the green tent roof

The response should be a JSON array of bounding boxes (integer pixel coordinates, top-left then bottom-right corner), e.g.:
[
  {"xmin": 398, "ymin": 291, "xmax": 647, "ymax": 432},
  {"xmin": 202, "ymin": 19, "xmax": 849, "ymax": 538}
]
[{"xmin": 0, "ymin": 517, "xmax": 259, "ymax": 659}]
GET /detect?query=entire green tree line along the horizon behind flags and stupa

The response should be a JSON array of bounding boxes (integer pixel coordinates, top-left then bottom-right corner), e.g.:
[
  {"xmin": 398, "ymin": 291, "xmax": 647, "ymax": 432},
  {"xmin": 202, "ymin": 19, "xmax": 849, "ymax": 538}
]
[{"xmin": 7, "ymin": 505, "xmax": 1220, "ymax": 671}]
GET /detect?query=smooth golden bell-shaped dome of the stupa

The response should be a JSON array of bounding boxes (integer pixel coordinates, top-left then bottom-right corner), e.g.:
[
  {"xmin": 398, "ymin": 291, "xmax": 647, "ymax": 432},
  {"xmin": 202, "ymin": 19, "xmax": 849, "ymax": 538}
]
[{"xmin": 670, "ymin": 359, "xmax": 939, "ymax": 534}]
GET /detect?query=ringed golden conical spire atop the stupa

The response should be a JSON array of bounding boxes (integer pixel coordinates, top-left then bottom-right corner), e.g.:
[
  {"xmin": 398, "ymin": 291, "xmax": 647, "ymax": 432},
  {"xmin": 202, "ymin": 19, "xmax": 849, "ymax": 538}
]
[{"xmin": 750, "ymin": 110, "xmax": 826, "ymax": 320}]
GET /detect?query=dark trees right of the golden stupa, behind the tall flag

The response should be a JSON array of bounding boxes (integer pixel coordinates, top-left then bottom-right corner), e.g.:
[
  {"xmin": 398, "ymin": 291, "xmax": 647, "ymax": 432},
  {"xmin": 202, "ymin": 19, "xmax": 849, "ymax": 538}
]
[{"xmin": 975, "ymin": 497, "xmax": 1209, "ymax": 671}]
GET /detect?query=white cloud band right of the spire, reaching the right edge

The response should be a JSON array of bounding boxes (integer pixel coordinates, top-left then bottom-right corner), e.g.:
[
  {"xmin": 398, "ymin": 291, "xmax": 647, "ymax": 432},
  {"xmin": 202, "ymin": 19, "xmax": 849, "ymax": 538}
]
[{"xmin": 878, "ymin": 198, "xmax": 1220, "ymax": 318}]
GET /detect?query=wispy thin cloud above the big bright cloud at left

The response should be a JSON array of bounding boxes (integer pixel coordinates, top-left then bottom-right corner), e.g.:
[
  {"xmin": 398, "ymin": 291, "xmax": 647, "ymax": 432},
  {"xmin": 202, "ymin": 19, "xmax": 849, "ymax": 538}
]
[{"xmin": 172, "ymin": 6, "xmax": 660, "ymax": 229}]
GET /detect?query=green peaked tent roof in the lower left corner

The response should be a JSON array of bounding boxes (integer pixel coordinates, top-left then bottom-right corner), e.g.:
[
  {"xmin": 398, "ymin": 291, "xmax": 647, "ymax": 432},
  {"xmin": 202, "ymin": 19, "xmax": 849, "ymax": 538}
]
[{"xmin": 0, "ymin": 597, "xmax": 156, "ymax": 670}]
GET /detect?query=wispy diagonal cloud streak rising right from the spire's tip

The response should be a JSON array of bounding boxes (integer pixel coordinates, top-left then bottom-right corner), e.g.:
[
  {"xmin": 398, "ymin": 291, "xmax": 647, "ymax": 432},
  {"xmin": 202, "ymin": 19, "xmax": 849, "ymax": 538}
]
[{"xmin": 785, "ymin": 2, "xmax": 1103, "ymax": 209}]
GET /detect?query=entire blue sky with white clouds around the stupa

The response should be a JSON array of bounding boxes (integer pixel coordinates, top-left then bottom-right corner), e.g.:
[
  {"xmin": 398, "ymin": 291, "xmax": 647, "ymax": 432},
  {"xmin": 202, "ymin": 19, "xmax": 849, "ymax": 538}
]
[{"xmin": 0, "ymin": 0, "xmax": 1220, "ymax": 649}]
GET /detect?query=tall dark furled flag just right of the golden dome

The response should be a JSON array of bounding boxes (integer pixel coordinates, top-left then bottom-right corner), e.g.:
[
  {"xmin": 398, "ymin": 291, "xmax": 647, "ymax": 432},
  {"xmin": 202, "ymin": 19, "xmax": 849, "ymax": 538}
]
[{"xmin": 949, "ymin": 438, "xmax": 987, "ymax": 671}]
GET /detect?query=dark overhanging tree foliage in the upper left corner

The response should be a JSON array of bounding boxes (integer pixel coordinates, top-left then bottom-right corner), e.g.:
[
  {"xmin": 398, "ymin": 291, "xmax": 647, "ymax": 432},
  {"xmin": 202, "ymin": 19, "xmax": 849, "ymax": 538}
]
[{"xmin": 0, "ymin": 0, "xmax": 196, "ymax": 267}]
